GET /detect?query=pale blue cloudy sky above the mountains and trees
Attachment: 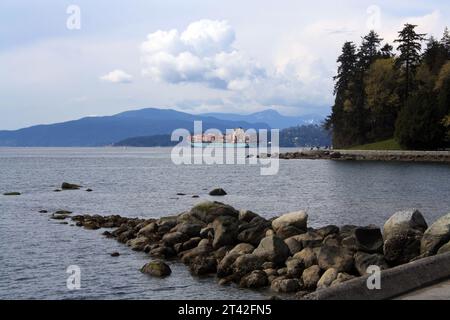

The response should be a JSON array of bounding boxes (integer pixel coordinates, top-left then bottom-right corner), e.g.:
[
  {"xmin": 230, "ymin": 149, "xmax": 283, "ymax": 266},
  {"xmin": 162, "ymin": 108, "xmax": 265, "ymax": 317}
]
[{"xmin": 0, "ymin": 0, "xmax": 450, "ymax": 130}]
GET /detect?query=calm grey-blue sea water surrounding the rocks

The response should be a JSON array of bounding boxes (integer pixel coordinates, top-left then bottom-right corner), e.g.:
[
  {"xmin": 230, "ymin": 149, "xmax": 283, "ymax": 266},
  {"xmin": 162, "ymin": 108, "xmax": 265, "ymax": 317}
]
[{"xmin": 0, "ymin": 148, "xmax": 450, "ymax": 299}]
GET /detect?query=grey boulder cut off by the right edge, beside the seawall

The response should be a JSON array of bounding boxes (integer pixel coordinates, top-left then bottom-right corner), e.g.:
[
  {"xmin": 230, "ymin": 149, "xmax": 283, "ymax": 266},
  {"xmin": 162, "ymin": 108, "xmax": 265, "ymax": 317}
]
[{"xmin": 420, "ymin": 213, "xmax": 450, "ymax": 256}]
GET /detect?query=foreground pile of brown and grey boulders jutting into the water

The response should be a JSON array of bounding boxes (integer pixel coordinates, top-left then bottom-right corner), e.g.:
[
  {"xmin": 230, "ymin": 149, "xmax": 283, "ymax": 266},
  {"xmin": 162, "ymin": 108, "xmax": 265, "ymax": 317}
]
[{"xmin": 57, "ymin": 202, "xmax": 450, "ymax": 299}]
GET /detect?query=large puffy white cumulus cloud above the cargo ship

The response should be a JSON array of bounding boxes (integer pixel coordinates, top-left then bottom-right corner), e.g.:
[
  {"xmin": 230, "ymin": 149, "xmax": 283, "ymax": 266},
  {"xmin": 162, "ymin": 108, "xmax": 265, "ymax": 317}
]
[{"xmin": 141, "ymin": 20, "xmax": 264, "ymax": 90}]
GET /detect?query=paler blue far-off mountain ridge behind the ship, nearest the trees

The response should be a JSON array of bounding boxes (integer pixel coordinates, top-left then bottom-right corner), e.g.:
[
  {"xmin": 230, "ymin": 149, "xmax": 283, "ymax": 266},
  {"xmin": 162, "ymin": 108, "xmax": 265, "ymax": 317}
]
[{"xmin": 202, "ymin": 109, "xmax": 324, "ymax": 129}]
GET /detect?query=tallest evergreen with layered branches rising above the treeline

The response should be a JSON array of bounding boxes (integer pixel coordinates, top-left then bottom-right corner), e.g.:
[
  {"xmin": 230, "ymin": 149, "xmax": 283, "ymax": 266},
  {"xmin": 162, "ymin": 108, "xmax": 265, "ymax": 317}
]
[{"xmin": 395, "ymin": 23, "xmax": 425, "ymax": 99}]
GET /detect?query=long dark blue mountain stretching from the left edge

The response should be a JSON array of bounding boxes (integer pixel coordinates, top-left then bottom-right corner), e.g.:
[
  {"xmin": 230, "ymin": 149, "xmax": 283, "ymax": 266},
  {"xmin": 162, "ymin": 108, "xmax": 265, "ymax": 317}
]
[{"xmin": 0, "ymin": 108, "xmax": 268, "ymax": 147}]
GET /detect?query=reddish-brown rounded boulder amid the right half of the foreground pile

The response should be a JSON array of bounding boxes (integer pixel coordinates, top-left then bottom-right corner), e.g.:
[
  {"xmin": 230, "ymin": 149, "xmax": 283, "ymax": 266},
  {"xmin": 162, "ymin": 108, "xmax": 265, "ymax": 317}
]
[{"xmin": 317, "ymin": 246, "xmax": 354, "ymax": 272}]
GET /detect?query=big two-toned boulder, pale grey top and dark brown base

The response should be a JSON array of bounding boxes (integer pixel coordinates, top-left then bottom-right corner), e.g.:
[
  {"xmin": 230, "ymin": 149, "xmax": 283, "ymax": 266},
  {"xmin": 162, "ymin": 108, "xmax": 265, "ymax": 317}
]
[{"xmin": 383, "ymin": 209, "xmax": 428, "ymax": 265}]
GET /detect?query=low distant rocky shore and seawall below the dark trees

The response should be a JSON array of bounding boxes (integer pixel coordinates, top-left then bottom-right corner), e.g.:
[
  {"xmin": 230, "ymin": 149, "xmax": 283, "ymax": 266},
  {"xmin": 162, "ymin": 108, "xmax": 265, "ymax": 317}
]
[{"xmin": 278, "ymin": 150, "xmax": 450, "ymax": 163}]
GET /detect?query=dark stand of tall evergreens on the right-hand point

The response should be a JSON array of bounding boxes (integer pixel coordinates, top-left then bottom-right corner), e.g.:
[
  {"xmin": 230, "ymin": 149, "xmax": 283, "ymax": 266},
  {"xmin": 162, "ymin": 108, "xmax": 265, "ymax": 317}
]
[{"xmin": 325, "ymin": 24, "xmax": 450, "ymax": 149}]
